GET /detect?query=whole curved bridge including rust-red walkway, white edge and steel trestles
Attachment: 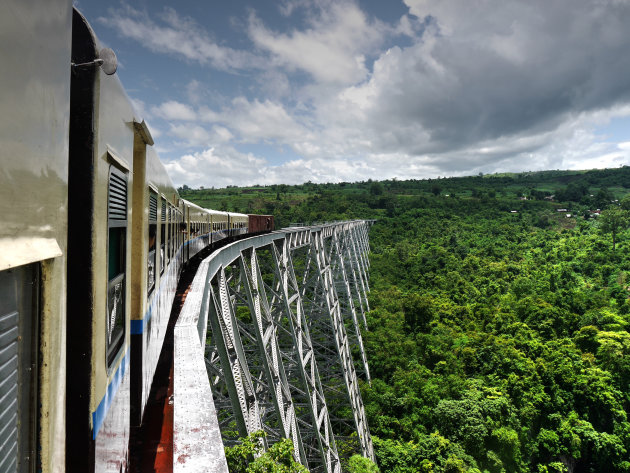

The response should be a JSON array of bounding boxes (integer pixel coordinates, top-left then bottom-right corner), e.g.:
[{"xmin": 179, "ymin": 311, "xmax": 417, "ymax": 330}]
[{"xmin": 130, "ymin": 221, "xmax": 373, "ymax": 473}]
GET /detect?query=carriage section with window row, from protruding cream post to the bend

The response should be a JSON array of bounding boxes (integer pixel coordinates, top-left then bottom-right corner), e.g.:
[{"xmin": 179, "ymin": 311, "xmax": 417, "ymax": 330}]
[{"xmin": 130, "ymin": 146, "xmax": 183, "ymax": 425}]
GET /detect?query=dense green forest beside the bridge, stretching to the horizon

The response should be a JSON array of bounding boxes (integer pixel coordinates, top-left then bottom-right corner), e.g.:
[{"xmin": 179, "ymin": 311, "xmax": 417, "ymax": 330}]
[{"xmin": 180, "ymin": 166, "xmax": 630, "ymax": 473}]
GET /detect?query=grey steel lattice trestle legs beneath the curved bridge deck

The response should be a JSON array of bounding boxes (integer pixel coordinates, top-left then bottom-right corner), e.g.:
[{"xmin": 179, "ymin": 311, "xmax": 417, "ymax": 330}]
[{"xmin": 188, "ymin": 221, "xmax": 374, "ymax": 473}]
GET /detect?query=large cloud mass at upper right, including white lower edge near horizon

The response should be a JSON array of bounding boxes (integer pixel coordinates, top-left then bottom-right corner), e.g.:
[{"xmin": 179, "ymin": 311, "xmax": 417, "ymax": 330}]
[{"xmin": 288, "ymin": 0, "xmax": 630, "ymax": 176}]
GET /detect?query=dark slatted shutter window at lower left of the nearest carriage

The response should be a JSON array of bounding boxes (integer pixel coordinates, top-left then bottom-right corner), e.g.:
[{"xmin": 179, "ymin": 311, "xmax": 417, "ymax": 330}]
[{"xmin": 0, "ymin": 265, "xmax": 39, "ymax": 473}]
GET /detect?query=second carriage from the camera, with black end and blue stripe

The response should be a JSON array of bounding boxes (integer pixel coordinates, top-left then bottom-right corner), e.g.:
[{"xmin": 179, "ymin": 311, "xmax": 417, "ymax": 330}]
[{"xmin": 66, "ymin": 6, "xmax": 182, "ymax": 473}]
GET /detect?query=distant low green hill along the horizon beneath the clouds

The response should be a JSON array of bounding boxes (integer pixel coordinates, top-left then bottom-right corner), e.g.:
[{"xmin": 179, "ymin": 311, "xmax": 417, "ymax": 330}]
[{"xmin": 179, "ymin": 166, "xmax": 630, "ymax": 226}]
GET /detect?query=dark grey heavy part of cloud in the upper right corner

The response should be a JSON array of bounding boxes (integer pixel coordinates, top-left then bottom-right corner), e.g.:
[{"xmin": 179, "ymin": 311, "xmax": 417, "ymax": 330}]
[{"xmin": 366, "ymin": 0, "xmax": 630, "ymax": 153}]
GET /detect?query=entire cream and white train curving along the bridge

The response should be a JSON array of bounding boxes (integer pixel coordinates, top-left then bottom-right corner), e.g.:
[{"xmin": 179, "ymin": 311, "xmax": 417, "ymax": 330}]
[{"xmin": 0, "ymin": 0, "xmax": 274, "ymax": 473}]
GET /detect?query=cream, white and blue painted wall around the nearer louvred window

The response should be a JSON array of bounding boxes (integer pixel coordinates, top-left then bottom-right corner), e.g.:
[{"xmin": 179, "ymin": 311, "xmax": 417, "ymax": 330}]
[{"xmin": 89, "ymin": 34, "xmax": 136, "ymax": 471}]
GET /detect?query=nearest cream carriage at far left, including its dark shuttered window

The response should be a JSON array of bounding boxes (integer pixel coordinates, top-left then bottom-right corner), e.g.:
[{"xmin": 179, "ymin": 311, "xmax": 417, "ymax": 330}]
[{"xmin": 0, "ymin": 0, "xmax": 72, "ymax": 472}]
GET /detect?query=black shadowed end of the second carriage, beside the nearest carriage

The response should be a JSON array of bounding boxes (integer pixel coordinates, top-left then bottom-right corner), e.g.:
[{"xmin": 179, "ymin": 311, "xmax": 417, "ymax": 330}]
[{"xmin": 65, "ymin": 10, "xmax": 97, "ymax": 473}]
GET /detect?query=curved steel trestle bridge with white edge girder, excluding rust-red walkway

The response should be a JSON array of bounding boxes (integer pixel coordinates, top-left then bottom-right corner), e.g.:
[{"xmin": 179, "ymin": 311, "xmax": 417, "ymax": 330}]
[{"xmin": 173, "ymin": 220, "xmax": 374, "ymax": 473}]
